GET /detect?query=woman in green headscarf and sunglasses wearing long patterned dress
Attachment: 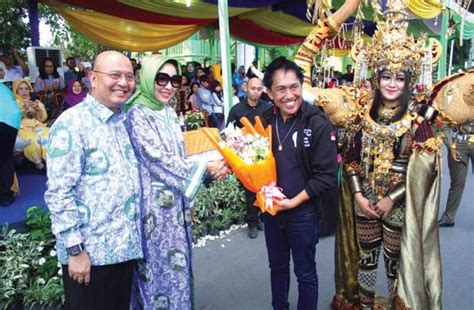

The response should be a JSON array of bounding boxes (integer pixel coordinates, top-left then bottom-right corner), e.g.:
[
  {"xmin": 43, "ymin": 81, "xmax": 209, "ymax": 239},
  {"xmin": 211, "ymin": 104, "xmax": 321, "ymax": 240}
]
[{"xmin": 126, "ymin": 55, "xmax": 228, "ymax": 310}]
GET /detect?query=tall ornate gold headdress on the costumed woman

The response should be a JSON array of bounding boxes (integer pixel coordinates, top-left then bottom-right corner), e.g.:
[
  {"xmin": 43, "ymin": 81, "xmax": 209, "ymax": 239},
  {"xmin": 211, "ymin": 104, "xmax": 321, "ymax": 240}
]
[{"xmin": 351, "ymin": 0, "xmax": 441, "ymax": 89}]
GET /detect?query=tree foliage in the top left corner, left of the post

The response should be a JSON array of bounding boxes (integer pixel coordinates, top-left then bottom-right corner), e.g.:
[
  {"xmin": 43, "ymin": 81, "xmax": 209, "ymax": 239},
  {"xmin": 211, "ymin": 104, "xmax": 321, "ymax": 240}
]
[{"xmin": 0, "ymin": 0, "xmax": 31, "ymax": 49}]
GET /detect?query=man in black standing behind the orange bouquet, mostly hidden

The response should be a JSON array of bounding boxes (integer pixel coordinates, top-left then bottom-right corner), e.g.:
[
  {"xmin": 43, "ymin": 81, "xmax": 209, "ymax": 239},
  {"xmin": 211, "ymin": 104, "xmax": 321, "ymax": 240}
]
[{"xmin": 227, "ymin": 76, "xmax": 273, "ymax": 239}]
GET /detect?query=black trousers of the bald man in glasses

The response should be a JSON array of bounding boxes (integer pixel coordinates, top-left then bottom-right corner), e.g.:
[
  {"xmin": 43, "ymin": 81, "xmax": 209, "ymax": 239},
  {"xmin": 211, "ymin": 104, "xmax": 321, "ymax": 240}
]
[{"xmin": 62, "ymin": 260, "xmax": 135, "ymax": 310}]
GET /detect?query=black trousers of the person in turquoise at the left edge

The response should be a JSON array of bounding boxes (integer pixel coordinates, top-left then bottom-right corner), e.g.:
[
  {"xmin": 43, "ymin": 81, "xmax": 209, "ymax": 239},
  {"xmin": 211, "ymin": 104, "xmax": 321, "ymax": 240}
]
[{"xmin": 0, "ymin": 123, "xmax": 18, "ymax": 196}]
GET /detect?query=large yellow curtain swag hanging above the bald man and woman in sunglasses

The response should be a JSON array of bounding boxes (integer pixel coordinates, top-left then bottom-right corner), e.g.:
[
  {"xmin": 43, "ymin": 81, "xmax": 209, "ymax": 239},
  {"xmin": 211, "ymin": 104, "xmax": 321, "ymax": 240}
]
[{"xmin": 50, "ymin": 5, "xmax": 201, "ymax": 51}]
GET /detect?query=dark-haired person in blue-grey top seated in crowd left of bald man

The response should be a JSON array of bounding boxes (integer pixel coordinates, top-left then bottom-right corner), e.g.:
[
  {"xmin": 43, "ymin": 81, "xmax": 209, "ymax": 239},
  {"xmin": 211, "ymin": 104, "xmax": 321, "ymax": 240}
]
[{"xmin": 35, "ymin": 58, "xmax": 64, "ymax": 93}]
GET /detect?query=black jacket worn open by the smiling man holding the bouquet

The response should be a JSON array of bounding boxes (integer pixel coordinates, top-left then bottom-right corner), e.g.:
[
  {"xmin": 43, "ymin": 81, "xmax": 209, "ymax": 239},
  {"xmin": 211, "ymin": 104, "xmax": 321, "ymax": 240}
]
[{"xmin": 263, "ymin": 102, "xmax": 338, "ymax": 205}]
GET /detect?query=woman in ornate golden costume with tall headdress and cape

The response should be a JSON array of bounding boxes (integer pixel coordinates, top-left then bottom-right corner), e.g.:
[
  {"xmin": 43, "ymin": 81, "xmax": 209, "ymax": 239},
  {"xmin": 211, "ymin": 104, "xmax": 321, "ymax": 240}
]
[{"xmin": 296, "ymin": 1, "xmax": 441, "ymax": 309}]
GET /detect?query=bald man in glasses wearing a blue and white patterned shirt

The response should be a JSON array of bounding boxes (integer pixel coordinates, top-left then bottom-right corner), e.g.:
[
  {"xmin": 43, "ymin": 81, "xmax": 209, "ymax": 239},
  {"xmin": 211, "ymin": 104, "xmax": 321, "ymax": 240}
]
[{"xmin": 45, "ymin": 51, "xmax": 143, "ymax": 310}]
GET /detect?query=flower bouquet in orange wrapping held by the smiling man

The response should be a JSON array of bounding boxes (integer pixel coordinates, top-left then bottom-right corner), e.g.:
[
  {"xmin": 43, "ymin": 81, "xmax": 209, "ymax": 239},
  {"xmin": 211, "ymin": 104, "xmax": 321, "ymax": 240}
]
[{"xmin": 204, "ymin": 117, "xmax": 286, "ymax": 215}]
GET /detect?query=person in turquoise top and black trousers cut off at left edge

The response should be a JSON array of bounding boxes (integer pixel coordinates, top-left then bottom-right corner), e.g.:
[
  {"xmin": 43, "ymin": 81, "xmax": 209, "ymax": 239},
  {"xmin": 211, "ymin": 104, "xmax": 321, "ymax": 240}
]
[{"xmin": 0, "ymin": 83, "xmax": 21, "ymax": 207}]
